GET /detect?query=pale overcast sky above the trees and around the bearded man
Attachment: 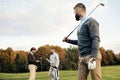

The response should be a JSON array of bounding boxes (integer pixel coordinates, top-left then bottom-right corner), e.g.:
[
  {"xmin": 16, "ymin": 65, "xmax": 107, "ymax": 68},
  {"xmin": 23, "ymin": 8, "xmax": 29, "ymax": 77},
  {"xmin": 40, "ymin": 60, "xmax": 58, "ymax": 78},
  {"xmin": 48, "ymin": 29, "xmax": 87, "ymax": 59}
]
[{"xmin": 0, "ymin": 0, "xmax": 120, "ymax": 53}]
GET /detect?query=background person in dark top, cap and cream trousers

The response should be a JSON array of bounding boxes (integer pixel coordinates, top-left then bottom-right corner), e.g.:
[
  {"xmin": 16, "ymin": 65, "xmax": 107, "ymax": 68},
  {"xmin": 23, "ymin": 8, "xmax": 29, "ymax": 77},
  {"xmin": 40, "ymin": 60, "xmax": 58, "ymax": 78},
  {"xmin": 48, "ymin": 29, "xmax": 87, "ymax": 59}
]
[{"xmin": 28, "ymin": 47, "xmax": 36, "ymax": 80}]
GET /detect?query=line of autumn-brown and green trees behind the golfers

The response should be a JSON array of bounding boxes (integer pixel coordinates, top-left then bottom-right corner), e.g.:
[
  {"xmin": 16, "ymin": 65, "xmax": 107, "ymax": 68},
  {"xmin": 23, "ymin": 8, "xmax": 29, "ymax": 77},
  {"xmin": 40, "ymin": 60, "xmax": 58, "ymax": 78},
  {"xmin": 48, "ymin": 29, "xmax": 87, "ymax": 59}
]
[{"xmin": 0, "ymin": 45, "xmax": 120, "ymax": 73}]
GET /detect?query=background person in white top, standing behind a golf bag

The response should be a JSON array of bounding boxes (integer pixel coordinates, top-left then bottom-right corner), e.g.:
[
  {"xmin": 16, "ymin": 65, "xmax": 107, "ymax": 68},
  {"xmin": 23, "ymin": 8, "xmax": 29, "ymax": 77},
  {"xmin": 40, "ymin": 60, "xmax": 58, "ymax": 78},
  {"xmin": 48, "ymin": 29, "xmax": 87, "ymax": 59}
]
[{"xmin": 46, "ymin": 49, "xmax": 60, "ymax": 80}]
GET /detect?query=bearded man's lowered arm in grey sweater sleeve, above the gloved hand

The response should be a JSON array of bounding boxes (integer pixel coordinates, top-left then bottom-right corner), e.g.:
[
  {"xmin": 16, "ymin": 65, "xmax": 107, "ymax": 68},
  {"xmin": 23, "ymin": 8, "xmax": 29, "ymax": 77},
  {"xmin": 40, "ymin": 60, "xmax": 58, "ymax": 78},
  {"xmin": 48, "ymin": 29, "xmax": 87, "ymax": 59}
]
[{"xmin": 89, "ymin": 20, "xmax": 100, "ymax": 57}]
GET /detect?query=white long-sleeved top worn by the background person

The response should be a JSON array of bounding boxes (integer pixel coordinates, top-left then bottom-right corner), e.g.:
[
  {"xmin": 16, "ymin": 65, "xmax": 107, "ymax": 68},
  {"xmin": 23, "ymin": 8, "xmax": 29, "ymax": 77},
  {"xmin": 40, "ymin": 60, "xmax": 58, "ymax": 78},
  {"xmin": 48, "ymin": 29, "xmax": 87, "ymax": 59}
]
[{"xmin": 48, "ymin": 52, "xmax": 60, "ymax": 67}]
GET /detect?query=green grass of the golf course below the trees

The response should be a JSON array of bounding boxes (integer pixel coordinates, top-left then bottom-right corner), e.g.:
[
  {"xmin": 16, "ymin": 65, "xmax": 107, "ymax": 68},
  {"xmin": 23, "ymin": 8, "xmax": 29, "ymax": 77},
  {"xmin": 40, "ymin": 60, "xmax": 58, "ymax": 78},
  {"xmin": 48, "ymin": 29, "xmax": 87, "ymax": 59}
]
[{"xmin": 0, "ymin": 66, "xmax": 120, "ymax": 80}]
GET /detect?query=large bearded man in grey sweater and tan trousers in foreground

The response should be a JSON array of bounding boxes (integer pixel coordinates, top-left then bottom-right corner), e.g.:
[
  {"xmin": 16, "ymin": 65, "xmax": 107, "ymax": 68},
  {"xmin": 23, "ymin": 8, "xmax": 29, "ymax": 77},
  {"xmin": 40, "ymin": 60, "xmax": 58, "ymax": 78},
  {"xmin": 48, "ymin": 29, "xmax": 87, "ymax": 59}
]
[{"xmin": 63, "ymin": 3, "xmax": 102, "ymax": 80}]
